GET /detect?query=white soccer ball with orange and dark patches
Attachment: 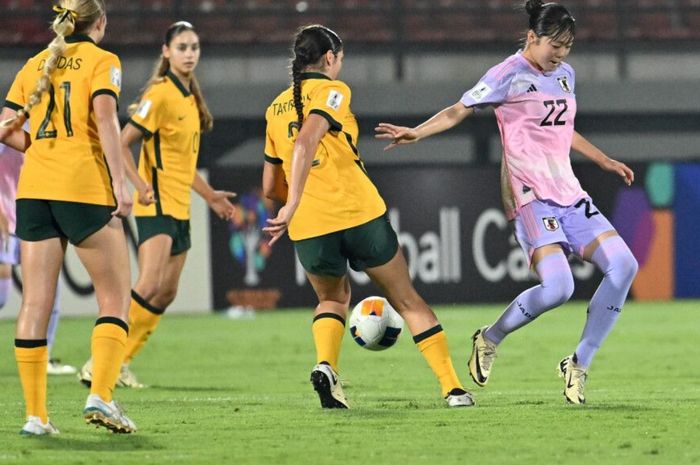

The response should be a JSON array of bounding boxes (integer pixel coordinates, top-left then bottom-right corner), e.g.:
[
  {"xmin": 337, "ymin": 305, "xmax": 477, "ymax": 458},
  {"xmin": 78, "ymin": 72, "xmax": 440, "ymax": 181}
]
[{"xmin": 350, "ymin": 296, "xmax": 403, "ymax": 350}]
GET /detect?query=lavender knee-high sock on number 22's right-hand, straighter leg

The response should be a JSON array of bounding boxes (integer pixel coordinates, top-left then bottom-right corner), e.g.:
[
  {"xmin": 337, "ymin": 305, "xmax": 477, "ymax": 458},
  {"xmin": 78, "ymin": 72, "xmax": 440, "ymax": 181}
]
[{"xmin": 574, "ymin": 236, "xmax": 638, "ymax": 367}]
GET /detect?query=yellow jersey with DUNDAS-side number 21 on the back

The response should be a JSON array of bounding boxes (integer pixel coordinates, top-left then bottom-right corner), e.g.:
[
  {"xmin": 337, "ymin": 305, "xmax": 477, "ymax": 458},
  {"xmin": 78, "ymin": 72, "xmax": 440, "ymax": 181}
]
[{"xmin": 5, "ymin": 35, "xmax": 121, "ymax": 206}]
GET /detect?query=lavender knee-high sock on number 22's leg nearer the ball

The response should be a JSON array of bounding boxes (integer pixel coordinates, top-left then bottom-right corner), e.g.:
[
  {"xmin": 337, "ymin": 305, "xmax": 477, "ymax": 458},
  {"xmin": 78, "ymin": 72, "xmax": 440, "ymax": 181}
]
[{"xmin": 484, "ymin": 253, "xmax": 574, "ymax": 344}]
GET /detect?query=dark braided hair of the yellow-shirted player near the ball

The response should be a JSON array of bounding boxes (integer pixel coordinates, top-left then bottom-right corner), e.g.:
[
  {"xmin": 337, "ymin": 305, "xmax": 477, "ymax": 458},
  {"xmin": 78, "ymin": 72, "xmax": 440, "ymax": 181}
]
[{"xmin": 290, "ymin": 24, "xmax": 343, "ymax": 128}]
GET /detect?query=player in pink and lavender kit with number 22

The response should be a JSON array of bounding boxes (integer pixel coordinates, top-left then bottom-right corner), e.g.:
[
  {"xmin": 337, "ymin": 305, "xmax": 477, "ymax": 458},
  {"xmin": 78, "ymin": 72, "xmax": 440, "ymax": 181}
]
[{"xmin": 377, "ymin": 0, "xmax": 637, "ymax": 404}]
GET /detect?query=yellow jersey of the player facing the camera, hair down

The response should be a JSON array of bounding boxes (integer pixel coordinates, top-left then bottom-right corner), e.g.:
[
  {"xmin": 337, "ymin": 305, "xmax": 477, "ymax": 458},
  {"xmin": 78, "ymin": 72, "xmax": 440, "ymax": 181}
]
[{"xmin": 129, "ymin": 72, "xmax": 200, "ymax": 220}]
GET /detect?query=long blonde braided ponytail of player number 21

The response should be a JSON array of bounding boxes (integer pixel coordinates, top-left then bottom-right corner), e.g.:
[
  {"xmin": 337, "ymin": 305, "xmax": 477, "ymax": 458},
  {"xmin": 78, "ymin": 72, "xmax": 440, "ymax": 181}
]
[{"xmin": 0, "ymin": 0, "xmax": 105, "ymax": 127}]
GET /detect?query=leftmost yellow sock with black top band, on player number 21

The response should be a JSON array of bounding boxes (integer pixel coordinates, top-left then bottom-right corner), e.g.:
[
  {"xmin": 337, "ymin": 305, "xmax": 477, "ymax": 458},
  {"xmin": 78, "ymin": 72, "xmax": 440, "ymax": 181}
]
[{"xmin": 15, "ymin": 339, "xmax": 49, "ymax": 424}]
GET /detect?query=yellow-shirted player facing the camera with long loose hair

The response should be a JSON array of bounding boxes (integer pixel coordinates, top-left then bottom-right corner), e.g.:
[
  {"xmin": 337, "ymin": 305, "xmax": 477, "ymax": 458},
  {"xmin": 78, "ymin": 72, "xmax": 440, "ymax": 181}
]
[{"xmin": 78, "ymin": 21, "xmax": 235, "ymax": 388}]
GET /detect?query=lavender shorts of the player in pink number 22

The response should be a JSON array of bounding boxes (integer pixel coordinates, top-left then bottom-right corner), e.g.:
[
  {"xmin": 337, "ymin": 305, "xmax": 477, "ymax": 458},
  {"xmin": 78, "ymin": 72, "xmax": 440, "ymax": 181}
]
[{"xmin": 515, "ymin": 197, "xmax": 615, "ymax": 261}]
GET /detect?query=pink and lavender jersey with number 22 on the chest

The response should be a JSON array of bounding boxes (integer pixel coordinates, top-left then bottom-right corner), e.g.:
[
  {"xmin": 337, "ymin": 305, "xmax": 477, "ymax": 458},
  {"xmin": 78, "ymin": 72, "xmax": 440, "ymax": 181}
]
[{"xmin": 461, "ymin": 52, "xmax": 587, "ymax": 219}]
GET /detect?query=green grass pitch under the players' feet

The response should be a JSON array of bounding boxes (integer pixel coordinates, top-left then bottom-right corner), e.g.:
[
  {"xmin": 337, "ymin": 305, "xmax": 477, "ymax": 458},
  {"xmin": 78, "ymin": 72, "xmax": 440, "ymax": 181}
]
[{"xmin": 0, "ymin": 301, "xmax": 700, "ymax": 465}]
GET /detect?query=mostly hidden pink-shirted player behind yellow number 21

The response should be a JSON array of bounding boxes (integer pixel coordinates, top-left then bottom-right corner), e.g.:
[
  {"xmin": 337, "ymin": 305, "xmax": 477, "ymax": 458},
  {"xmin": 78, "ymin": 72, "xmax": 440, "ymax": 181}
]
[{"xmin": 0, "ymin": 130, "xmax": 77, "ymax": 375}]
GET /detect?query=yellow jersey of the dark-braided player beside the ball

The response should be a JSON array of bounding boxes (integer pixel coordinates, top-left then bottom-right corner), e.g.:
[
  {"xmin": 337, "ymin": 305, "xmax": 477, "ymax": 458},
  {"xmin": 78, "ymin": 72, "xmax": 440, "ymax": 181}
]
[{"xmin": 265, "ymin": 73, "xmax": 386, "ymax": 241}]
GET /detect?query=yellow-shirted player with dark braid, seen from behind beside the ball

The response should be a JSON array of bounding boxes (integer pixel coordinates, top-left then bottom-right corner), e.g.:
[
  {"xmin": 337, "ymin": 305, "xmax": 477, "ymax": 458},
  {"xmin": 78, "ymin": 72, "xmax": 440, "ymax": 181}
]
[{"xmin": 263, "ymin": 25, "xmax": 474, "ymax": 408}]
